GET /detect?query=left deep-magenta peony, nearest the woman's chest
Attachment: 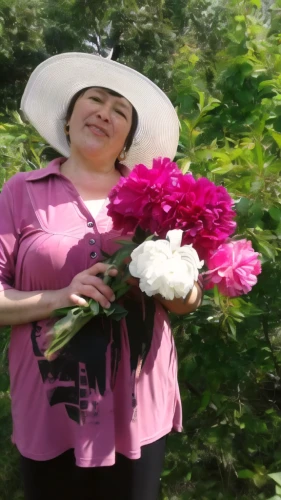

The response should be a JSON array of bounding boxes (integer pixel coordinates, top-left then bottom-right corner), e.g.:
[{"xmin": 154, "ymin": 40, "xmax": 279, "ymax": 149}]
[{"xmin": 108, "ymin": 158, "xmax": 182, "ymax": 234}]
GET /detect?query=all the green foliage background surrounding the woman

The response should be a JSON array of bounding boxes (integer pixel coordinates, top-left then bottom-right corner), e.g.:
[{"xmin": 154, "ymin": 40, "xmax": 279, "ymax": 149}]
[{"xmin": 0, "ymin": 0, "xmax": 281, "ymax": 500}]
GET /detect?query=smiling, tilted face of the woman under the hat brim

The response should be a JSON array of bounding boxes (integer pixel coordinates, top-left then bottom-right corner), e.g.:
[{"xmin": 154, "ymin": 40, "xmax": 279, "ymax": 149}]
[{"xmin": 68, "ymin": 88, "xmax": 132, "ymax": 162}]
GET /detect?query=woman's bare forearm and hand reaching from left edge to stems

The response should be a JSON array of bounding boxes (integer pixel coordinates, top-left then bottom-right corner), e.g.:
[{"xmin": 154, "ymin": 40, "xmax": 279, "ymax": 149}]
[{"xmin": 0, "ymin": 262, "xmax": 117, "ymax": 325}]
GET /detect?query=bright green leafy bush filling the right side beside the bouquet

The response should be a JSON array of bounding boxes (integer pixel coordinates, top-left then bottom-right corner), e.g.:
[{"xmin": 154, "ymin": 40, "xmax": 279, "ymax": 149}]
[{"xmin": 161, "ymin": 1, "xmax": 281, "ymax": 500}]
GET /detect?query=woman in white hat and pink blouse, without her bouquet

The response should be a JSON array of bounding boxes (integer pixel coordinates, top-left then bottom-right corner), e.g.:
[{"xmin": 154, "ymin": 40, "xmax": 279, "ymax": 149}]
[{"xmin": 0, "ymin": 53, "xmax": 201, "ymax": 500}]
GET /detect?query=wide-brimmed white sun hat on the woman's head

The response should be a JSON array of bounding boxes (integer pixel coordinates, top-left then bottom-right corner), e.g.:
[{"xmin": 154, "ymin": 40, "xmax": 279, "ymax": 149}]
[{"xmin": 21, "ymin": 52, "xmax": 179, "ymax": 168}]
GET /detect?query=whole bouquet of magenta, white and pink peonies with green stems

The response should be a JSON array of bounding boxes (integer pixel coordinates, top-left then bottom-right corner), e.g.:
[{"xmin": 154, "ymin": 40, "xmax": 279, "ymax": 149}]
[{"xmin": 45, "ymin": 158, "xmax": 261, "ymax": 359}]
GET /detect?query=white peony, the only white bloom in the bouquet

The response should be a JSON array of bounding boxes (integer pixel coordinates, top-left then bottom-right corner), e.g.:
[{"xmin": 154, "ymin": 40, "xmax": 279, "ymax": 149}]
[{"xmin": 129, "ymin": 229, "xmax": 204, "ymax": 300}]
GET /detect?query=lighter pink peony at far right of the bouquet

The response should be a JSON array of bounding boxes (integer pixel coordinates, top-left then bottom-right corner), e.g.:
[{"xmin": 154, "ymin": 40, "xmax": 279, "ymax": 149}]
[{"xmin": 204, "ymin": 240, "xmax": 261, "ymax": 297}]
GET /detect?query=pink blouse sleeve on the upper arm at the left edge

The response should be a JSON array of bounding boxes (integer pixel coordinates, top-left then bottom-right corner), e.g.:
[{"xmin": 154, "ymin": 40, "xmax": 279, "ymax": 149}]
[{"xmin": 0, "ymin": 182, "xmax": 19, "ymax": 291}]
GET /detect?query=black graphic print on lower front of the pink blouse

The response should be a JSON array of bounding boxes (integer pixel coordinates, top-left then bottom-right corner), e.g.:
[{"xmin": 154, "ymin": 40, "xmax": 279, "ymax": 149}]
[{"xmin": 31, "ymin": 297, "xmax": 155, "ymax": 425}]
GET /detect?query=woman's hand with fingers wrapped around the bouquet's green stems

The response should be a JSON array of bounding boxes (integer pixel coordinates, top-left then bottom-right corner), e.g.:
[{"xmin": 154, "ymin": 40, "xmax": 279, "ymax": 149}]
[{"xmin": 59, "ymin": 262, "xmax": 118, "ymax": 308}]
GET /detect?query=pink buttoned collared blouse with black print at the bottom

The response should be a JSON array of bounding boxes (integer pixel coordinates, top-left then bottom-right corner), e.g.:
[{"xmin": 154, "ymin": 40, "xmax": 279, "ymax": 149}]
[{"xmin": 0, "ymin": 158, "xmax": 182, "ymax": 467}]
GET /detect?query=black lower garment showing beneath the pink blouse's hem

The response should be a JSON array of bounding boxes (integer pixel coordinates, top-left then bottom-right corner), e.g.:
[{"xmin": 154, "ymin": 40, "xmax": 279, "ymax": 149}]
[{"xmin": 21, "ymin": 436, "xmax": 166, "ymax": 500}]
